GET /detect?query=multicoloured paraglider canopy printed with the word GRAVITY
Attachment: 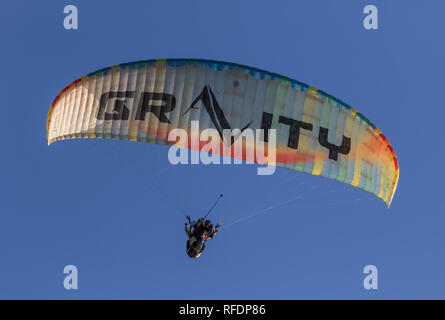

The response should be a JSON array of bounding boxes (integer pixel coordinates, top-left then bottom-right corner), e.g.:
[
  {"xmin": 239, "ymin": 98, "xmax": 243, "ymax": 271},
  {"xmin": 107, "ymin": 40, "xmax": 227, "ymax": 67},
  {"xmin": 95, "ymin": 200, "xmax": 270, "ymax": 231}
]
[{"xmin": 47, "ymin": 59, "xmax": 399, "ymax": 206}]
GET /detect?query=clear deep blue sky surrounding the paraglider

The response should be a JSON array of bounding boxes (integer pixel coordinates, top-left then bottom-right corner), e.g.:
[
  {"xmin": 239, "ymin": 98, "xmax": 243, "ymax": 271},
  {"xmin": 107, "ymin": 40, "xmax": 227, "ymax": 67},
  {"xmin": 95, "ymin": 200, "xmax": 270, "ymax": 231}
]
[{"xmin": 0, "ymin": 0, "xmax": 445, "ymax": 299}]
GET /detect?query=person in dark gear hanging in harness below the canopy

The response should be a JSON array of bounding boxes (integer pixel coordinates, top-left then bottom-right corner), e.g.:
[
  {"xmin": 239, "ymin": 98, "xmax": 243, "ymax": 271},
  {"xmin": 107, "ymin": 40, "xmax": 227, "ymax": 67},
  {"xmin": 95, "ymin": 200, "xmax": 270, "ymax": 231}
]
[{"xmin": 185, "ymin": 194, "xmax": 223, "ymax": 258}]
